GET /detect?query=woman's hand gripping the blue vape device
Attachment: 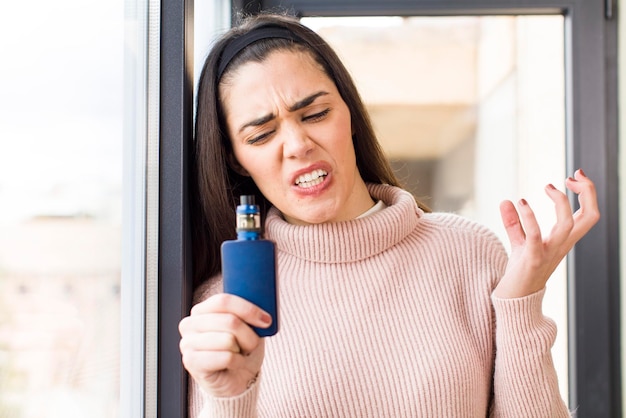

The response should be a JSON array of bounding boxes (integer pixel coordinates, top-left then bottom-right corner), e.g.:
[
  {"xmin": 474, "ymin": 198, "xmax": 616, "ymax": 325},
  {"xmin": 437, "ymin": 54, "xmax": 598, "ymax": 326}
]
[{"xmin": 178, "ymin": 293, "xmax": 272, "ymax": 397}]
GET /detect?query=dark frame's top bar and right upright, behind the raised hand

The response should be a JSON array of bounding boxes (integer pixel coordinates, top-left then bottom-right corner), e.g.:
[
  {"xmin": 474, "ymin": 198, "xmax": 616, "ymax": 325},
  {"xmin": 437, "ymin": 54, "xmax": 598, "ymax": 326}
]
[{"xmin": 222, "ymin": 0, "xmax": 622, "ymax": 417}]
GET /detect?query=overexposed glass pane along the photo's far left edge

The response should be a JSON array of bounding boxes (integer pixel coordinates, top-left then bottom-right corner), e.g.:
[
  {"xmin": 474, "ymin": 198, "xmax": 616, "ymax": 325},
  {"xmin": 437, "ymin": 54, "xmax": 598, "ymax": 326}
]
[{"xmin": 0, "ymin": 0, "xmax": 125, "ymax": 418}]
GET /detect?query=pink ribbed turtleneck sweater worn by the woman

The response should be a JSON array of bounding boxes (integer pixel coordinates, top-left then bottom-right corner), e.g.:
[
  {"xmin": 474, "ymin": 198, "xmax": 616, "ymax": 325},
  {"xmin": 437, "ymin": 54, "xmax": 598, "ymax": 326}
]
[{"xmin": 189, "ymin": 185, "xmax": 569, "ymax": 418}]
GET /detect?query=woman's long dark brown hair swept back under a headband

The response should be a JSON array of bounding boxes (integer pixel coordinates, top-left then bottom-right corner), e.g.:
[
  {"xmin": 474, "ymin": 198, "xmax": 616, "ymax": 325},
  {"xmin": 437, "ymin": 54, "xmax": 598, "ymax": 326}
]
[{"xmin": 190, "ymin": 14, "xmax": 425, "ymax": 286}]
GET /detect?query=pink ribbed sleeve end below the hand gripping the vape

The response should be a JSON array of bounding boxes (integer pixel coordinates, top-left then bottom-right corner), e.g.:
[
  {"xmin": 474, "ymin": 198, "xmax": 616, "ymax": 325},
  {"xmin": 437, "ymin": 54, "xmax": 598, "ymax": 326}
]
[{"xmin": 188, "ymin": 375, "xmax": 261, "ymax": 418}]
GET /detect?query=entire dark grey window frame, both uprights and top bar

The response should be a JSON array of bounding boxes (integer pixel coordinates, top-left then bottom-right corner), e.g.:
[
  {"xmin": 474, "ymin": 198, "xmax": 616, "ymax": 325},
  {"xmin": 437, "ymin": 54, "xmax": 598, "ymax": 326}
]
[{"xmin": 154, "ymin": 0, "xmax": 622, "ymax": 418}]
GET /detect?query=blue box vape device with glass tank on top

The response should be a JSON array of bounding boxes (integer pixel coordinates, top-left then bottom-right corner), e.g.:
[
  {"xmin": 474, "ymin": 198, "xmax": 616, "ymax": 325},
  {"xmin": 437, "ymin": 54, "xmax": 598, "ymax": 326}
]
[{"xmin": 221, "ymin": 195, "xmax": 278, "ymax": 337}]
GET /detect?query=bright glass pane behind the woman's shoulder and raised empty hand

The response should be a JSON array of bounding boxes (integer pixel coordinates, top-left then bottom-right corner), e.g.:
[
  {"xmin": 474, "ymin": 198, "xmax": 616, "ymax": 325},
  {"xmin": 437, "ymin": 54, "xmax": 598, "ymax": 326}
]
[{"xmin": 302, "ymin": 16, "xmax": 568, "ymax": 399}]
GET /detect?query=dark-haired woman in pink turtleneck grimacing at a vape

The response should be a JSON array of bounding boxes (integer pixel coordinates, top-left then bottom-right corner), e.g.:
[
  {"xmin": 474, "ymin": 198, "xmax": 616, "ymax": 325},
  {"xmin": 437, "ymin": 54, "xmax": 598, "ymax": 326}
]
[{"xmin": 180, "ymin": 11, "xmax": 599, "ymax": 418}]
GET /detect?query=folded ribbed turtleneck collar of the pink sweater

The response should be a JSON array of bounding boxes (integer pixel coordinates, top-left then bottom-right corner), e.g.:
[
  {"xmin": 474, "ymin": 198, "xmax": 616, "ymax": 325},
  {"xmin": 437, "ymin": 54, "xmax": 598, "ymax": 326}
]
[{"xmin": 265, "ymin": 184, "xmax": 423, "ymax": 263}]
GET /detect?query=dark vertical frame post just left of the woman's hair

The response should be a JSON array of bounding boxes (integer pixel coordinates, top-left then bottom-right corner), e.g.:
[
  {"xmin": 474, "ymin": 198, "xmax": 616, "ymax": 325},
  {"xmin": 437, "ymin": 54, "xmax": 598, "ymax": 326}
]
[{"xmin": 157, "ymin": 0, "xmax": 194, "ymax": 418}]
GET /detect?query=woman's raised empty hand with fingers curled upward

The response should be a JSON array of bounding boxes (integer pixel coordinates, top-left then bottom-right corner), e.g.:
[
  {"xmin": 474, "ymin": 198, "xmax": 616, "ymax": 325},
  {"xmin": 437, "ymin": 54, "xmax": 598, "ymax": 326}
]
[{"xmin": 494, "ymin": 170, "xmax": 600, "ymax": 298}]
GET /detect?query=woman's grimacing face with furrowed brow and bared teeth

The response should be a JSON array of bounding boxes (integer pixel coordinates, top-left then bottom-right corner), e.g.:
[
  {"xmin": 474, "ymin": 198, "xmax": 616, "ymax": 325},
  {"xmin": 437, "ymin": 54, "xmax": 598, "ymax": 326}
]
[{"xmin": 220, "ymin": 50, "xmax": 373, "ymax": 224}]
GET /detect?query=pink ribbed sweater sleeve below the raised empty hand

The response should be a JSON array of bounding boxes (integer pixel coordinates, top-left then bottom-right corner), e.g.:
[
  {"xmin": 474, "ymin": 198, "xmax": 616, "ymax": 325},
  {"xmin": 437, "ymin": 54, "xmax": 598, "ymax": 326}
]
[{"xmin": 490, "ymin": 288, "xmax": 570, "ymax": 418}]
